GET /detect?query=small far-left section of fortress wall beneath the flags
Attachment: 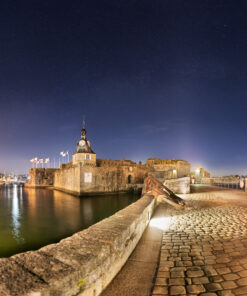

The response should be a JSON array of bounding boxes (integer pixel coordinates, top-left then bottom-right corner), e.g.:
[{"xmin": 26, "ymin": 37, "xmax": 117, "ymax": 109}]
[{"xmin": 25, "ymin": 168, "xmax": 57, "ymax": 187}]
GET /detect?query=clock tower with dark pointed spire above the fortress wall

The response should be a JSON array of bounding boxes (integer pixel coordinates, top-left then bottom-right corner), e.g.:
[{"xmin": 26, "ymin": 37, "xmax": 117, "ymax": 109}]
[{"xmin": 72, "ymin": 119, "xmax": 96, "ymax": 166}]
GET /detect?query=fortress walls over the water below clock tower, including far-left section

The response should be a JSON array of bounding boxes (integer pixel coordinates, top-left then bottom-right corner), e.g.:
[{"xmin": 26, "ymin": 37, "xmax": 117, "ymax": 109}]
[{"xmin": 26, "ymin": 162, "xmax": 149, "ymax": 195}]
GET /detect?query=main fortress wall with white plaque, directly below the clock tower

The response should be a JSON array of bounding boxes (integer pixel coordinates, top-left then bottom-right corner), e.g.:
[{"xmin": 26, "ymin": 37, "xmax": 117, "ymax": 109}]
[{"xmin": 54, "ymin": 164, "xmax": 148, "ymax": 195}]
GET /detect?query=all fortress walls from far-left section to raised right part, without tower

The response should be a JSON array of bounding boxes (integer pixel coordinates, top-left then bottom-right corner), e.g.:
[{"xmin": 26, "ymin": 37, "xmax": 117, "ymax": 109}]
[{"xmin": 27, "ymin": 159, "xmax": 190, "ymax": 195}]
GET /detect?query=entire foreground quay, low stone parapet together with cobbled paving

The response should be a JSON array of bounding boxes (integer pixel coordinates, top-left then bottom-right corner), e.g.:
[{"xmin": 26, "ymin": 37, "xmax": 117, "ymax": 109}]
[{"xmin": 0, "ymin": 185, "xmax": 247, "ymax": 296}]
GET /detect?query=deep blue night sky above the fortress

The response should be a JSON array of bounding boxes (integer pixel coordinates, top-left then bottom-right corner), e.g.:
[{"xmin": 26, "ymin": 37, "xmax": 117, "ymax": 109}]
[{"xmin": 0, "ymin": 0, "xmax": 247, "ymax": 175}]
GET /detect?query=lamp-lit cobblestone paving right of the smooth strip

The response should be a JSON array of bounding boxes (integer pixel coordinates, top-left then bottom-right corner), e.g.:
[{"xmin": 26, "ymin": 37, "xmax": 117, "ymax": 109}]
[{"xmin": 152, "ymin": 188, "xmax": 247, "ymax": 296}]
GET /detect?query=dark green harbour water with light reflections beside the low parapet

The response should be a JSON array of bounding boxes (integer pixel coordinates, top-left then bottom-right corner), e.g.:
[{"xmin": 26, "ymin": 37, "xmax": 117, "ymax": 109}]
[{"xmin": 0, "ymin": 186, "xmax": 138, "ymax": 257}]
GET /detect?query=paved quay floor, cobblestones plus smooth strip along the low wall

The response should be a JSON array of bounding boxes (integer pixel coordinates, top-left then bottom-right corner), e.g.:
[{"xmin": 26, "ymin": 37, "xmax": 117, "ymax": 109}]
[{"xmin": 102, "ymin": 185, "xmax": 247, "ymax": 296}]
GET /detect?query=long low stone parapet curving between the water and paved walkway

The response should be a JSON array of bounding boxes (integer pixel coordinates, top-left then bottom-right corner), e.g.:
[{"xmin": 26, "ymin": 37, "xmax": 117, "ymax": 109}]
[{"xmin": 0, "ymin": 195, "xmax": 155, "ymax": 296}]
